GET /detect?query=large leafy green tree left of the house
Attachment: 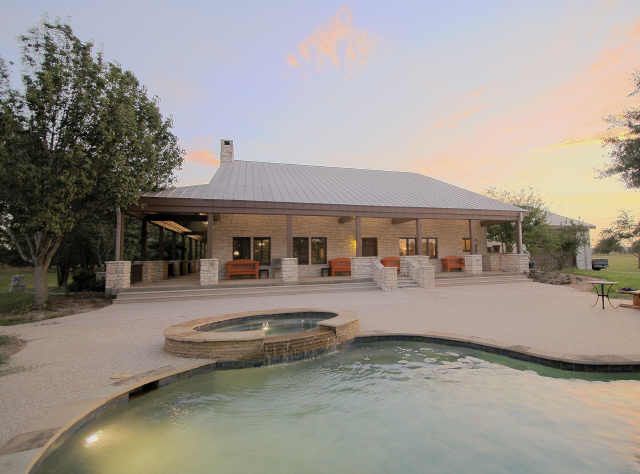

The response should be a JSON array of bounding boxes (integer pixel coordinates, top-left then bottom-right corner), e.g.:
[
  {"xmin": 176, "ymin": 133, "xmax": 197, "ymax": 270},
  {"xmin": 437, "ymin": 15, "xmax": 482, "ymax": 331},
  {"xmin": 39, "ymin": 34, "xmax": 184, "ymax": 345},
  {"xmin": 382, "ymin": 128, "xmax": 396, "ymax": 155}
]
[{"xmin": 0, "ymin": 23, "xmax": 184, "ymax": 306}]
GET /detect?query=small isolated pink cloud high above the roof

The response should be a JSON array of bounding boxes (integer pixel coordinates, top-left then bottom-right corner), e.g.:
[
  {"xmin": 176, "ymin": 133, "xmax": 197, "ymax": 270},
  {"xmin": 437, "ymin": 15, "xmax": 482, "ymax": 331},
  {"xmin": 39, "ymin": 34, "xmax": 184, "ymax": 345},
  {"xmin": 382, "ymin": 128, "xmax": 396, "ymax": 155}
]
[{"xmin": 287, "ymin": 7, "xmax": 375, "ymax": 71}]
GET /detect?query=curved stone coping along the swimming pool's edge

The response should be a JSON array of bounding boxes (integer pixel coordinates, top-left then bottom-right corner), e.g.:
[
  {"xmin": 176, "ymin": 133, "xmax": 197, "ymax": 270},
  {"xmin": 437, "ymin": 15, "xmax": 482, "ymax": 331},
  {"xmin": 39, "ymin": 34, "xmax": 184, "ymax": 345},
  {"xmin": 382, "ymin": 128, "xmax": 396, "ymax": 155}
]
[{"xmin": 25, "ymin": 331, "xmax": 640, "ymax": 474}]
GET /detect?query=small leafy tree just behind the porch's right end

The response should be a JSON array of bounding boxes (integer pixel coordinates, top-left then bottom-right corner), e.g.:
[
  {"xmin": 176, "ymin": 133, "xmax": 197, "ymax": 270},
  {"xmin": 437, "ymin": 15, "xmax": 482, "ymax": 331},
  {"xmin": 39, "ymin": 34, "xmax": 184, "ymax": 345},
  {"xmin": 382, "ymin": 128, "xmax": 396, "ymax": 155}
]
[{"xmin": 487, "ymin": 188, "xmax": 549, "ymax": 252}]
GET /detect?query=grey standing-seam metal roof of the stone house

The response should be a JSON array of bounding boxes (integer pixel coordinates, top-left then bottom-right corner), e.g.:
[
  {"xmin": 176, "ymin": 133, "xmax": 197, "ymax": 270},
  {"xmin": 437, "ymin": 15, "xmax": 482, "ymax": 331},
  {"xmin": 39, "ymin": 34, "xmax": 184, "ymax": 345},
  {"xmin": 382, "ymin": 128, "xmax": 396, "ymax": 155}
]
[{"xmin": 141, "ymin": 160, "xmax": 522, "ymax": 217}]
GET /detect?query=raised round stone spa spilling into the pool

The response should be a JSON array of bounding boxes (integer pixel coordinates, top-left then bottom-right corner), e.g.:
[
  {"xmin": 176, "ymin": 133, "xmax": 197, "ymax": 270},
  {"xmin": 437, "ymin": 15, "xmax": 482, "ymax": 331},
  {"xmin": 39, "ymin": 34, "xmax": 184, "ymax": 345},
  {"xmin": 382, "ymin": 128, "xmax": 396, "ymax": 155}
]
[{"xmin": 165, "ymin": 308, "xmax": 359, "ymax": 367}]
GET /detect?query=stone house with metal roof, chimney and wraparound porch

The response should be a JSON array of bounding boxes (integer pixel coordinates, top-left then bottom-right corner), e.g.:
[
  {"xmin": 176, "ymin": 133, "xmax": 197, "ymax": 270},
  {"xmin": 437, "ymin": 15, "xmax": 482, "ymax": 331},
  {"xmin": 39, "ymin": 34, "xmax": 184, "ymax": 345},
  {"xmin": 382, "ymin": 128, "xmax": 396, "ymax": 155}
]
[{"xmin": 107, "ymin": 139, "xmax": 525, "ymax": 288}]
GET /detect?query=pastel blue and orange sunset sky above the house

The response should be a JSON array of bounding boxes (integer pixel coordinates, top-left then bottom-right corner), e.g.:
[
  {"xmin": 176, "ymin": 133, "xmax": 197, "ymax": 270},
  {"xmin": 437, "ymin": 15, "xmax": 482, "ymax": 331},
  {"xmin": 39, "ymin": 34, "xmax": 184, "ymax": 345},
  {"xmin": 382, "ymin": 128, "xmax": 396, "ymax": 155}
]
[{"xmin": 0, "ymin": 0, "xmax": 640, "ymax": 238}]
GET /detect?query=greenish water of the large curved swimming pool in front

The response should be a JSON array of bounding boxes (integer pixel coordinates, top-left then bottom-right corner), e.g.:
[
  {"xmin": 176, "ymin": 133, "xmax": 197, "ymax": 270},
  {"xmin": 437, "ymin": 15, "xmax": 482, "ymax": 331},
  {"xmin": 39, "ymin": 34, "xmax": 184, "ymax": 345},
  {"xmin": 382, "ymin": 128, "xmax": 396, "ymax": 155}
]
[{"xmin": 39, "ymin": 341, "xmax": 640, "ymax": 474}]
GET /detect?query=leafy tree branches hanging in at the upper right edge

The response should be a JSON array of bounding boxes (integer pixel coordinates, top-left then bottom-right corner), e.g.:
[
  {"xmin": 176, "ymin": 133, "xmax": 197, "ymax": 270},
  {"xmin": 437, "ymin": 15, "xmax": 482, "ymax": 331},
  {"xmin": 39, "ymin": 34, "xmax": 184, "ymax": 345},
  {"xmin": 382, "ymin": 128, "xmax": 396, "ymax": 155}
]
[{"xmin": 603, "ymin": 72, "xmax": 640, "ymax": 188}]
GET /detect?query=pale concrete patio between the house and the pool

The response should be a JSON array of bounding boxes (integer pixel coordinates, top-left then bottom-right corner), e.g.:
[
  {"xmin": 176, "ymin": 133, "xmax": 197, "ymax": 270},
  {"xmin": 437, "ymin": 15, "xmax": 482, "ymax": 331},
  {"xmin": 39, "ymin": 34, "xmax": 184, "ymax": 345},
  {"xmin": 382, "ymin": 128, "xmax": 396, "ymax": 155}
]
[{"xmin": 0, "ymin": 282, "xmax": 640, "ymax": 473}]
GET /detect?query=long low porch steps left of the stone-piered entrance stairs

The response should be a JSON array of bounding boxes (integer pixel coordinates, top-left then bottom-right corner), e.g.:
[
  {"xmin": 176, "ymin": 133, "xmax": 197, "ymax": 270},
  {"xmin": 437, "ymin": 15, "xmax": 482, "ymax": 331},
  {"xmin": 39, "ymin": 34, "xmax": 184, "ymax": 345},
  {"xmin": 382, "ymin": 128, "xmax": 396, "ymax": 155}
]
[{"xmin": 113, "ymin": 280, "xmax": 379, "ymax": 304}]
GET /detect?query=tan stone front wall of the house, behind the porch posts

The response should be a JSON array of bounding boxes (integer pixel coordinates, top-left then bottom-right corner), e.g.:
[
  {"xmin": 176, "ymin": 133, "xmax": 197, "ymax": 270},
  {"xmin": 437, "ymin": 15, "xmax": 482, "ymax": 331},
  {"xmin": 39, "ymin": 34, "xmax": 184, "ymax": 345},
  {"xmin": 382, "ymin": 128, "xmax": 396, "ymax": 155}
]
[{"xmin": 213, "ymin": 214, "xmax": 486, "ymax": 277}]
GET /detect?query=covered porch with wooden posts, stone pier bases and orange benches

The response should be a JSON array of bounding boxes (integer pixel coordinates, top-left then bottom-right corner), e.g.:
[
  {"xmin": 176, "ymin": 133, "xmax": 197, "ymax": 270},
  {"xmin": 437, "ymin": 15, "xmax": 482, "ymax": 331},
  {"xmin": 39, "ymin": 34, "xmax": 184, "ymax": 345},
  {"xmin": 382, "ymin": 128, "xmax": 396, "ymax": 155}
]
[{"xmin": 107, "ymin": 197, "xmax": 528, "ymax": 292}]
